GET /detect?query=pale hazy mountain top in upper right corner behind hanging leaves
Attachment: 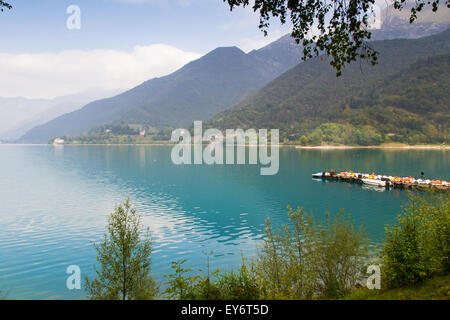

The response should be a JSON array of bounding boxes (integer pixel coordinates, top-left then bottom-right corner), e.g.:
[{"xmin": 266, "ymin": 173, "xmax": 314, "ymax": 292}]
[{"xmin": 372, "ymin": 3, "xmax": 450, "ymax": 40}]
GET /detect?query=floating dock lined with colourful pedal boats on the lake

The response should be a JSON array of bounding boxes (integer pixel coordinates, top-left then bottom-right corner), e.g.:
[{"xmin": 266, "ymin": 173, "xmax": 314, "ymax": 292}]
[{"xmin": 312, "ymin": 170, "xmax": 450, "ymax": 191}]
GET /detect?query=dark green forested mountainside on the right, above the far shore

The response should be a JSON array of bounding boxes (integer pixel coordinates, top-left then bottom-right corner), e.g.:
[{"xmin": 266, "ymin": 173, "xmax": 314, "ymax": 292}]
[{"xmin": 205, "ymin": 29, "xmax": 450, "ymax": 142}]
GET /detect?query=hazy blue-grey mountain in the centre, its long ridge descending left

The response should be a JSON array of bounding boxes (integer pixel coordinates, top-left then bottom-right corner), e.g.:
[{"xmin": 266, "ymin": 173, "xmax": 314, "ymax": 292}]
[{"xmin": 20, "ymin": 36, "xmax": 302, "ymax": 142}]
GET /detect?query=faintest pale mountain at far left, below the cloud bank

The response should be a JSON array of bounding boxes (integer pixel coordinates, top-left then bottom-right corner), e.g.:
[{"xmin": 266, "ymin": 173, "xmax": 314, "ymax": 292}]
[{"xmin": 0, "ymin": 89, "xmax": 117, "ymax": 141}]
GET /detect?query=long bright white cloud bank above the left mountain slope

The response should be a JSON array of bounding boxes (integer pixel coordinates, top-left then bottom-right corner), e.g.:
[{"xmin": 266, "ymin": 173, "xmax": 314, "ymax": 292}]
[{"xmin": 0, "ymin": 44, "xmax": 200, "ymax": 98}]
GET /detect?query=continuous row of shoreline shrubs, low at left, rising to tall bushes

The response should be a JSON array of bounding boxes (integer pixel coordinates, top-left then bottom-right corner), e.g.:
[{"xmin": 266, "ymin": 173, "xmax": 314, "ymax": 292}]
[{"xmin": 164, "ymin": 208, "xmax": 368, "ymax": 300}]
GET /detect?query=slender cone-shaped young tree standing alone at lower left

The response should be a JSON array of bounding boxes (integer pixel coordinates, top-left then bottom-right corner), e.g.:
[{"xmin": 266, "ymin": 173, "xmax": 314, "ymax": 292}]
[{"xmin": 85, "ymin": 199, "xmax": 158, "ymax": 300}]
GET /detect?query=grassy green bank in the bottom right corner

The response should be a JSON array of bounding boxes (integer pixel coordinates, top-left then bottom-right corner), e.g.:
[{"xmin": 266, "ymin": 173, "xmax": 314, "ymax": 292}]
[{"xmin": 345, "ymin": 274, "xmax": 450, "ymax": 300}]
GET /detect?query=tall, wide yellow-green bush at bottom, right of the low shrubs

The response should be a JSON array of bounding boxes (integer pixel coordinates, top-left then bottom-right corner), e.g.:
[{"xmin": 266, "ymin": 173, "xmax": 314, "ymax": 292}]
[{"xmin": 255, "ymin": 208, "xmax": 368, "ymax": 299}]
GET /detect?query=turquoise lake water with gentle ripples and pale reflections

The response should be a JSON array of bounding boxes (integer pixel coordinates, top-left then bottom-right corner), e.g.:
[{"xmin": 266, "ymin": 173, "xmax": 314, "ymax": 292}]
[{"xmin": 0, "ymin": 145, "xmax": 450, "ymax": 299}]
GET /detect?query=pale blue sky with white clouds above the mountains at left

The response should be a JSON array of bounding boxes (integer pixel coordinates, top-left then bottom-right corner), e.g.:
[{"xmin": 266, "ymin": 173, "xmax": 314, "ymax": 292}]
[{"xmin": 0, "ymin": 0, "xmax": 290, "ymax": 98}]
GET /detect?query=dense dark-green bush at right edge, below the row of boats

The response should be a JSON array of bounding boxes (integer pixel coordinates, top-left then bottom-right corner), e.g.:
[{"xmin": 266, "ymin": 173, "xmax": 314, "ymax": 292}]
[{"xmin": 381, "ymin": 192, "xmax": 450, "ymax": 288}]
